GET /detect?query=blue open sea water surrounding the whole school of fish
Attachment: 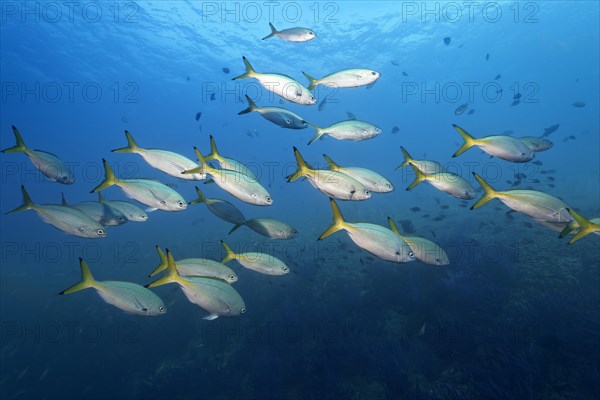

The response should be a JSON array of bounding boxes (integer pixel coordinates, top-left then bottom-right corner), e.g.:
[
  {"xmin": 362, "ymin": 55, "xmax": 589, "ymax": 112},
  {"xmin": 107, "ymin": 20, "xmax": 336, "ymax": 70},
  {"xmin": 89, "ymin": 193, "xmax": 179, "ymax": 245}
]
[{"xmin": 0, "ymin": 1, "xmax": 600, "ymax": 399}]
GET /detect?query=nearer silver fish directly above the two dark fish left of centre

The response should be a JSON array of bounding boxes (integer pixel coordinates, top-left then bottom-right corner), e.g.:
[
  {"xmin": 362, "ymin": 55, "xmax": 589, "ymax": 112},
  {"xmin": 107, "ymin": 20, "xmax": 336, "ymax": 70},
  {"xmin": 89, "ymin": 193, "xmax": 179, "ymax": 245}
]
[{"xmin": 182, "ymin": 147, "xmax": 273, "ymax": 206}]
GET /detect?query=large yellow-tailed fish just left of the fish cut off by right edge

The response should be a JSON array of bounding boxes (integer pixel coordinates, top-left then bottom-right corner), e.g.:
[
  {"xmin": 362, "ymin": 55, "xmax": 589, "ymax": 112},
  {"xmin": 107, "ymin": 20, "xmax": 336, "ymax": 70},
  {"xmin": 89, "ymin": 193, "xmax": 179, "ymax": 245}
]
[{"xmin": 471, "ymin": 172, "xmax": 573, "ymax": 222}]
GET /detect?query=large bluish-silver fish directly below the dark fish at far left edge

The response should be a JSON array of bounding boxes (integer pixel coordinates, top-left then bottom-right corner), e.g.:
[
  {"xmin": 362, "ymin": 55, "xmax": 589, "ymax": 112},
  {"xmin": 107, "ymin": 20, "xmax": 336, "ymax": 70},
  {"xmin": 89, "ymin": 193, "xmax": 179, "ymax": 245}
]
[{"xmin": 6, "ymin": 185, "xmax": 107, "ymax": 239}]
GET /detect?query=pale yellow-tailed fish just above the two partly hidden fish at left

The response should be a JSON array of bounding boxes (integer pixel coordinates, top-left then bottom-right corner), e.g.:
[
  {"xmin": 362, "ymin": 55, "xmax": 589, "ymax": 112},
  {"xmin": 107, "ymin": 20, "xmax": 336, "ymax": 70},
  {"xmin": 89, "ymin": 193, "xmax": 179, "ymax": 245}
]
[{"xmin": 90, "ymin": 159, "xmax": 187, "ymax": 211}]
